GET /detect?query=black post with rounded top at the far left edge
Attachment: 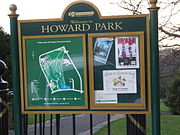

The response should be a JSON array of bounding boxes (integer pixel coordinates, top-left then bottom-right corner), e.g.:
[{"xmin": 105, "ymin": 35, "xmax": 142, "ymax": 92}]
[{"xmin": 0, "ymin": 60, "xmax": 9, "ymax": 135}]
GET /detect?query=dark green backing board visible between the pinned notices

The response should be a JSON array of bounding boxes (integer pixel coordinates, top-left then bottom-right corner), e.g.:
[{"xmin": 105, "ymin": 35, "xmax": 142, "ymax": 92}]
[{"xmin": 93, "ymin": 37, "xmax": 142, "ymax": 103}]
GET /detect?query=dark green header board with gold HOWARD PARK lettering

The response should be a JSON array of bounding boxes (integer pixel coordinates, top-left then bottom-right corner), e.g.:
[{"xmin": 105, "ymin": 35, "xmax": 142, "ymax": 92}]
[{"xmin": 21, "ymin": 17, "xmax": 146, "ymax": 36}]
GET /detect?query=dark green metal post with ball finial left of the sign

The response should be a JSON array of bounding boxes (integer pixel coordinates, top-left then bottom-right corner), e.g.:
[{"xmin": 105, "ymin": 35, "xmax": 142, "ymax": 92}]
[{"xmin": 9, "ymin": 4, "xmax": 22, "ymax": 135}]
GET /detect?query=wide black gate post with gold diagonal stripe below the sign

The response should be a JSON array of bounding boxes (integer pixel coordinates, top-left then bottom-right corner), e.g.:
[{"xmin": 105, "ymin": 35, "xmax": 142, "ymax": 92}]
[{"xmin": 127, "ymin": 114, "xmax": 146, "ymax": 135}]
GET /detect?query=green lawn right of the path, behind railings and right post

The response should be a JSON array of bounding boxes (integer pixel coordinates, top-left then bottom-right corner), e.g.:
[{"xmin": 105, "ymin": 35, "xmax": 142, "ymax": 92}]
[{"xmin": 95, "ymin": 102, "xmax": 180, "ymax": 135}]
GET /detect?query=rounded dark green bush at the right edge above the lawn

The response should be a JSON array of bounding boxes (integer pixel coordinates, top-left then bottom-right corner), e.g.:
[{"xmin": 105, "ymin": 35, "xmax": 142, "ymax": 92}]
[{"xmin": 165, "ymin": 75, "xmax": 180, "ymax": 114}]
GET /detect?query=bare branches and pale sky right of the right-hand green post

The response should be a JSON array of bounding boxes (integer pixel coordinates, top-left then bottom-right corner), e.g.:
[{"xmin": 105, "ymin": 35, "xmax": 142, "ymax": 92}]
[{"xmin": 159, "ymin": 0, "xmax": 180, "ymax": 48}]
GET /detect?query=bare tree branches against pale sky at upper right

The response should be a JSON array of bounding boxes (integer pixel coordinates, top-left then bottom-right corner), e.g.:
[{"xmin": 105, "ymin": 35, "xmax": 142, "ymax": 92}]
[{"xmin": 111, "ymin": 0, "xmax": 180, "ymax": 49}]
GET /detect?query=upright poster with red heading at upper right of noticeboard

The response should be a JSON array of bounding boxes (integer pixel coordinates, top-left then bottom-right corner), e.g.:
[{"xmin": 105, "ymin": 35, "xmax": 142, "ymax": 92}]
[{"xmin": 115, "ymin": 36, "xmax": 139, "ymax": 68}]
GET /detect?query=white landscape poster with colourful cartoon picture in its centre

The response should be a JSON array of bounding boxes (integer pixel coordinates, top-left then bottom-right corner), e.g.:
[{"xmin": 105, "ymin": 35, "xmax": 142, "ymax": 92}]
[{"xmin": 103, "ymin": 69, "xmax": 137, "ymax": 93}]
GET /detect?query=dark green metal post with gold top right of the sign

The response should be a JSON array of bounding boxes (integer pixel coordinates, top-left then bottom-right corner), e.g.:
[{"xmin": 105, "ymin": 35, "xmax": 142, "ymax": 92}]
[{"xmin": 149, "ymin": 0, "xmax": 160, "ymax": 135}]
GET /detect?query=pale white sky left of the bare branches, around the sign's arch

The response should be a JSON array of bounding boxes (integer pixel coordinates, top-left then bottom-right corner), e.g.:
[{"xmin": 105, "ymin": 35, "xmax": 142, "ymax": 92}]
[{"xmin": 0, "ymin": 0, "xmax": 125, "ymax": 33}]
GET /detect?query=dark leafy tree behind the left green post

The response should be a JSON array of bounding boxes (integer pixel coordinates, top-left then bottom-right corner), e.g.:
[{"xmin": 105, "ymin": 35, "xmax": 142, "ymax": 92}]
[{"xmin": 0, "ymin": 27, "xmax": 12, "ymax": 88}]
